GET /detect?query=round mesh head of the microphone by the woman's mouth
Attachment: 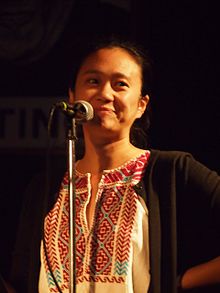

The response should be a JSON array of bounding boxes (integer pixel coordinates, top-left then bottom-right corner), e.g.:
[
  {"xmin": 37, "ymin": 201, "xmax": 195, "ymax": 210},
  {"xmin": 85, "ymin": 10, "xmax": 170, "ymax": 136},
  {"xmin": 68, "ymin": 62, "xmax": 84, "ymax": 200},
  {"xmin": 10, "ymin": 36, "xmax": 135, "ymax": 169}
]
[{"xmin": 73, "ymin": 100, "xmax": 94, "ymax": 123}]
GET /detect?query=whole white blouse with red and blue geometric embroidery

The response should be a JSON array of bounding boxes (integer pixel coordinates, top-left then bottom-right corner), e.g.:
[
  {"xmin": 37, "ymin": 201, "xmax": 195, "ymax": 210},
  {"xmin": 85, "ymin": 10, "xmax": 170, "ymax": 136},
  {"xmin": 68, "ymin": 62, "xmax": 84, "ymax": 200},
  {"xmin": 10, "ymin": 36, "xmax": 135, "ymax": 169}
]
[{"xmin": 39, "ymin": 151, "xmax": 150, "ymax": 293}]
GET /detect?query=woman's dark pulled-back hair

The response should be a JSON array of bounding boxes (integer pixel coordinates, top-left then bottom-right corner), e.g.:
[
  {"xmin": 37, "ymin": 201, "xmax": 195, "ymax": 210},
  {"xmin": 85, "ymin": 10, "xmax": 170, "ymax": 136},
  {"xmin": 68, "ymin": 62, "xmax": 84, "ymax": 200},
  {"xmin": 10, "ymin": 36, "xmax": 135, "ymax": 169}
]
[{"xmin": 69, "ymin": 37, "xmax": 152, "ymax": 148}]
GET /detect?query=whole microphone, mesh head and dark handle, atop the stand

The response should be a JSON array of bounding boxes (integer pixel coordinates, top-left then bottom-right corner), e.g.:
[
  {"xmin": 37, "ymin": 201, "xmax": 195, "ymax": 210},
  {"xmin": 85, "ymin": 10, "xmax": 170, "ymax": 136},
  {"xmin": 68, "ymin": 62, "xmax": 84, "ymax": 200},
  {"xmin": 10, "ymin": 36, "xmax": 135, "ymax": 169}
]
[{"xmin": 54, "ymin": 100, "xmax": 94, "ymax": 123}]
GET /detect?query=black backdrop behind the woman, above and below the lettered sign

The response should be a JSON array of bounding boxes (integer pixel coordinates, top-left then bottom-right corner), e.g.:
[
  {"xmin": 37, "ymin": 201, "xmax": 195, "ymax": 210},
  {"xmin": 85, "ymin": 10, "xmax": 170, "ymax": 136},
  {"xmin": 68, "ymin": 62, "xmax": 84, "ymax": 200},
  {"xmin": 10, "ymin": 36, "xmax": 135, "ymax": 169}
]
[{"xmin": 0, "ymin": 0, "xmax": 220, "ymax": 275}]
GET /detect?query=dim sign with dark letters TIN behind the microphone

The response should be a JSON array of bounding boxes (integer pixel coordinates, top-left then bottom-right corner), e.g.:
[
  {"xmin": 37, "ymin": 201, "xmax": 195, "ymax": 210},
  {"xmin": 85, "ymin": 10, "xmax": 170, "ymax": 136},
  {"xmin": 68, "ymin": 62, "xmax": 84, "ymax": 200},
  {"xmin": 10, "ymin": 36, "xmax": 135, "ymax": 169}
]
[{"xmin": 0, "ymin": 97, "xmax": 66, "ymax": 150}]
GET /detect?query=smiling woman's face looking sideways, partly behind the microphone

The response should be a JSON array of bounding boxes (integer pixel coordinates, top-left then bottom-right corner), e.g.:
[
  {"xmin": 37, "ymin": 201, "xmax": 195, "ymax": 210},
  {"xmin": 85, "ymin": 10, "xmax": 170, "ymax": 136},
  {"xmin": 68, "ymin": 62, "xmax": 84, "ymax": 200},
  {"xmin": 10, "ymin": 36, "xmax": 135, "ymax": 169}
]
[{"xmin": 70, "ymin": 48, "xmax": 148, "ymax": 136}]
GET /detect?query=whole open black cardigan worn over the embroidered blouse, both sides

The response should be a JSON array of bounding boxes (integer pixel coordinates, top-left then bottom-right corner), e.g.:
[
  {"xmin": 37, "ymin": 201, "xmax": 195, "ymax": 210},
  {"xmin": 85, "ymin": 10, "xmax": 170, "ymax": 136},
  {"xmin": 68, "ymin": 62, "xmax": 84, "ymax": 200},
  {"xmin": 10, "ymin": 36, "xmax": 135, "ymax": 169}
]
[{"xmin": 9, "ymin": 150, "xmax": 220, "ymax": 293}]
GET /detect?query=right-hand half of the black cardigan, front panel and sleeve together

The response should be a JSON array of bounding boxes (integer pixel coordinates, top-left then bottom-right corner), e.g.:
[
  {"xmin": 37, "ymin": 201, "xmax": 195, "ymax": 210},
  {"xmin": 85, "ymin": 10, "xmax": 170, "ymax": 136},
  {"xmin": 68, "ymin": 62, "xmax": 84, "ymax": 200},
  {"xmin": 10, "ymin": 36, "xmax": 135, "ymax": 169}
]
[{"xmin": 144, "ymin": 150, "xmax": 220, "ymax": 293}]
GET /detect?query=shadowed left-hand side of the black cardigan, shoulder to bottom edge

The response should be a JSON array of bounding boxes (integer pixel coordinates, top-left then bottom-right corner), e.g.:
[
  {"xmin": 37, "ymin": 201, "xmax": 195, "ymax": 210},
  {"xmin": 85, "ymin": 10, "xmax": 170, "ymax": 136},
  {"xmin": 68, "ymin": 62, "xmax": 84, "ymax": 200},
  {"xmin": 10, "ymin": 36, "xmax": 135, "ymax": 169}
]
[{"xmin": 10, "ymin": 159, "xmax": 65, "ymax": 293}]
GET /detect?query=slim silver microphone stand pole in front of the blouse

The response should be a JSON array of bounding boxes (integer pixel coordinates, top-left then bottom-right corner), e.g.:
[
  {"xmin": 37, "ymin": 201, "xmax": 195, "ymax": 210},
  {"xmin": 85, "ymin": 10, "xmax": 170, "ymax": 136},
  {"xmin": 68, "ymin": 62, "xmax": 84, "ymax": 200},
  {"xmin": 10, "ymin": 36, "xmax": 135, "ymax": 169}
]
[{"xmin": 67, "ymin": 117, "xmax": 77, "ymax": 293}]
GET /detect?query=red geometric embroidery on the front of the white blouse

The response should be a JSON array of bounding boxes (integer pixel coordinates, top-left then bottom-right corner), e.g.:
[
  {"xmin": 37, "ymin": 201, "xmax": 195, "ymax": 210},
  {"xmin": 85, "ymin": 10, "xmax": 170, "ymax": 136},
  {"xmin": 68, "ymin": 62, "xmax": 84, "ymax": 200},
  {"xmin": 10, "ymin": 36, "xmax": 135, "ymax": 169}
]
[{"xmin": 43, "ymin": 151, "xmax": 149, "ymax": 292}]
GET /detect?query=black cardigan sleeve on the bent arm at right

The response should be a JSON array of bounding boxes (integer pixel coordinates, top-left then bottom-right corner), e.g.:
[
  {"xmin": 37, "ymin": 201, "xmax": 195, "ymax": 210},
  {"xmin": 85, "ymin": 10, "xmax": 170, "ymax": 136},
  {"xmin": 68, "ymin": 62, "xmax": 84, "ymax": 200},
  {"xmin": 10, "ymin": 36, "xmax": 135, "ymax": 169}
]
[{"xmin": 175, "ymin": 154, "xmax": 220, "ymax": 268}]
